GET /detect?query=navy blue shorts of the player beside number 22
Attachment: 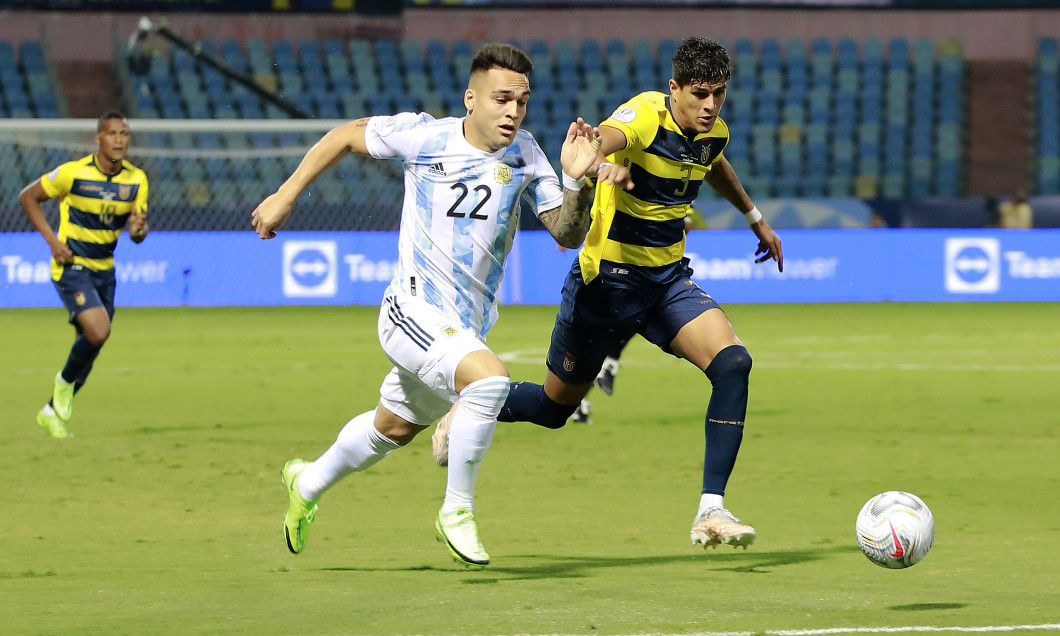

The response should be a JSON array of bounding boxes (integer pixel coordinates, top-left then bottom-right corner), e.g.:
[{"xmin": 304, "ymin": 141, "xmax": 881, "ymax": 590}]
[{"xmin": 546, "ymin": 259, "xmax": 719, "ymax": 385}]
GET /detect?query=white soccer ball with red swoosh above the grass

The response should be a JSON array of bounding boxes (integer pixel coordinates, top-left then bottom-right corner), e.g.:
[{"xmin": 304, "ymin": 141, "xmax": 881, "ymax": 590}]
[{"xmin": 854, "ymin": 491, "xmax": 935, "ymax": 569}]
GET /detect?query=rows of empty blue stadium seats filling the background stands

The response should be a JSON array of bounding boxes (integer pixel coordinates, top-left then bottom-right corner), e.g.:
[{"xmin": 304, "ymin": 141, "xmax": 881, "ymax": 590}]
[{"xmin": 0, "ymin": 33, "xmax": 1060, "ymax": 225}]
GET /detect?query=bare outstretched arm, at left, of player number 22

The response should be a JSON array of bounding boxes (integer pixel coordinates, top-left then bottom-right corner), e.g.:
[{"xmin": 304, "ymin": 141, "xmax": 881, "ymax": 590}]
[{"xmin": 250, "ymin": 117, "xmax": 371, "ymax": 239}]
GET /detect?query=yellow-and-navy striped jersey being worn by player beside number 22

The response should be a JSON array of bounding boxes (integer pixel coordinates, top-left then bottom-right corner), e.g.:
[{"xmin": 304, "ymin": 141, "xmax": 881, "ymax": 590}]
[{"xmin": 578, "ymin": 91, "xmax": 728, "ymax": 283}]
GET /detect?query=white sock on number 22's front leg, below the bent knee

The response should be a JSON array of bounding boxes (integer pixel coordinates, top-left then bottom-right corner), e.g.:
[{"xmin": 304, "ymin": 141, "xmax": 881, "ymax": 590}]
[{"xmin": 442, "ymin": 375, "xmax": 511, "ymax": 512}]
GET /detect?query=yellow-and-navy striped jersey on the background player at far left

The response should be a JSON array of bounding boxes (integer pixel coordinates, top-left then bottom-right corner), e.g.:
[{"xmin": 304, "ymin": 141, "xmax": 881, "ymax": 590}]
[{"xmin": 40, "ymin": 154, "xmax": 147, "ymax": 281}]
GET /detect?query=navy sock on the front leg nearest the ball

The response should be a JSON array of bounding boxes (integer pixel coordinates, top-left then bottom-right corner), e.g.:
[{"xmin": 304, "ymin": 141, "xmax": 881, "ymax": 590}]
[{"xmin": 703, "ymin": 345, "xmax": 750, "ymax": 495}]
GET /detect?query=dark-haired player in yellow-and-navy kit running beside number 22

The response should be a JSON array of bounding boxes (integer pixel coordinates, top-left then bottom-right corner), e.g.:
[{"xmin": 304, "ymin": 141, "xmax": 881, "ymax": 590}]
[{"xmin": 499, "ymin": 38, "xmax": 783, "ymax": 547}]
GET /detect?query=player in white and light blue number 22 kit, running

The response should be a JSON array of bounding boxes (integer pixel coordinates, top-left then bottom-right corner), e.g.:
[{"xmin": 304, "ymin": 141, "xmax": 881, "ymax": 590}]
[{"xmin": 252, "ymin": 43, "xmax": 629, "ymax": 567}]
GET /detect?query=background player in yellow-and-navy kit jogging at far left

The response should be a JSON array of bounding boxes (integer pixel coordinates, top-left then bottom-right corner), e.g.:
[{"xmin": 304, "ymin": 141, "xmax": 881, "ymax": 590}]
[{"xmin": 18, "ymin": 111, "xmax": 147, "ymax": 438}]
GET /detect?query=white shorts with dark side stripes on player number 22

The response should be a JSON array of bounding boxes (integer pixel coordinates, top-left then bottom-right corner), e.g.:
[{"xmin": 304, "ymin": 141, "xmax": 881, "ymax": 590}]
[{"xmin": 379, "ymin": 287, "xmax": 489, "ymax": 426}]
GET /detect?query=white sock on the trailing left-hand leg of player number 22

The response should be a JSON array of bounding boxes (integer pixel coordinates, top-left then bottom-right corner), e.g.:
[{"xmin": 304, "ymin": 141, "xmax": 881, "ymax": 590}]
[{"xmin": 298, "ymin": 410, "xmax": 399, "ymax": 501}]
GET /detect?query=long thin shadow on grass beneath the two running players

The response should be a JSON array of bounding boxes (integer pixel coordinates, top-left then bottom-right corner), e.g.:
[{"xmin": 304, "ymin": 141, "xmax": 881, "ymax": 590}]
[{"xmin": 320, "ymin": 546, "xmax": 858, "ymax": 584}]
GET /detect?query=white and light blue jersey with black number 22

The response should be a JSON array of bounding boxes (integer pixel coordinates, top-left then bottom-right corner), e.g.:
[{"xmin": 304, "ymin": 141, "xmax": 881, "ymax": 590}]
[{"xmin": 365, "ymin": 112, "xmax": 563, "ymax": 337}]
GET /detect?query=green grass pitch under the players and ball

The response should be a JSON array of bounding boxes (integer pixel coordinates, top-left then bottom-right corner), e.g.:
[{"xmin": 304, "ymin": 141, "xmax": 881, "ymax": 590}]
[{"xmin": 0, "ymin": 303, "xmax": 1060, "ymax": 636}]
